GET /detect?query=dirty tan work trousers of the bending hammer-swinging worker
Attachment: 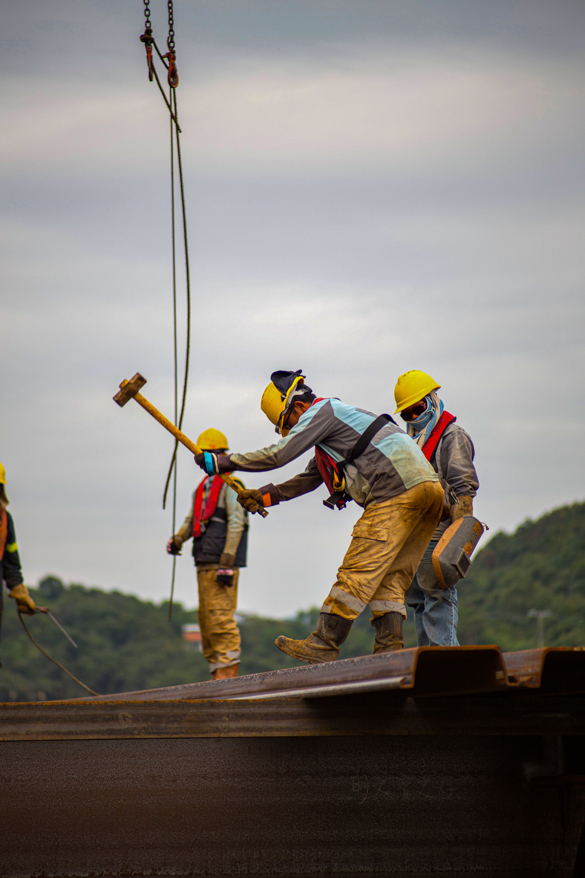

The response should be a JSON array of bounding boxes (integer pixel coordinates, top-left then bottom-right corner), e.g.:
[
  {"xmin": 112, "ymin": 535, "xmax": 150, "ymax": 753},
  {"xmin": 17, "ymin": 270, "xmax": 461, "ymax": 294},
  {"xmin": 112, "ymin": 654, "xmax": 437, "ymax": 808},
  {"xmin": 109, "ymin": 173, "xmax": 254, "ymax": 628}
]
[{"xmin": 321, "ymin": 482, "xmax": 443, "ymax": 619}]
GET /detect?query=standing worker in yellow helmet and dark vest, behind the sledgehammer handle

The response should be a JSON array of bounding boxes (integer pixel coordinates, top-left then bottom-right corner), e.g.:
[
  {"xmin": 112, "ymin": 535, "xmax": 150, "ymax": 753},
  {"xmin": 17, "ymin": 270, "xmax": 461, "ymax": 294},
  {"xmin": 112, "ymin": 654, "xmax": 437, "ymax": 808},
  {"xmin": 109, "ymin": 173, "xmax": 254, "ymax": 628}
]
[{"xmin": 167, "ymin": 429, "xmax": 248, "ymax": 680}]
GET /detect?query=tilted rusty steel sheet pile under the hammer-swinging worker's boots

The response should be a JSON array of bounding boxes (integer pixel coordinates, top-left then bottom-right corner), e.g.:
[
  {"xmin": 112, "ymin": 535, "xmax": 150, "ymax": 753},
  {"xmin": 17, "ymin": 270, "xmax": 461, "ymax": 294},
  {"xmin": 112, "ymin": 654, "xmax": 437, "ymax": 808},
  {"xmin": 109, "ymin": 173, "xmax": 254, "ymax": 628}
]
[{"xmin": 80, "ymin": 646, "xmax": 507, "ymax": 701}]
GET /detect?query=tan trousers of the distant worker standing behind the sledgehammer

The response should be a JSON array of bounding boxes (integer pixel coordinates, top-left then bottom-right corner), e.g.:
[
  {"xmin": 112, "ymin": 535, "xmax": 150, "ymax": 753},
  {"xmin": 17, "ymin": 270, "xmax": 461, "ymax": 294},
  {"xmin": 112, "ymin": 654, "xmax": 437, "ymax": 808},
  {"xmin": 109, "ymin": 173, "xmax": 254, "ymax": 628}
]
[{"xmin": 197, "ymin": 567, "xmax": 241, "ymax": 672}]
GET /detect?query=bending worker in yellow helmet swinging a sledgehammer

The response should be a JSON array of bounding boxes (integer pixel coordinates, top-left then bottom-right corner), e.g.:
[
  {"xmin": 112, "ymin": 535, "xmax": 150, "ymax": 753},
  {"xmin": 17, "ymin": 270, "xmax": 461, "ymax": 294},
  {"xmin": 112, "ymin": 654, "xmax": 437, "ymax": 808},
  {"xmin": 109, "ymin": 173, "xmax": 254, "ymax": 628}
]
[{"xmin": 195, "ymin": 369, "xmax": 443, "ymax": 663}]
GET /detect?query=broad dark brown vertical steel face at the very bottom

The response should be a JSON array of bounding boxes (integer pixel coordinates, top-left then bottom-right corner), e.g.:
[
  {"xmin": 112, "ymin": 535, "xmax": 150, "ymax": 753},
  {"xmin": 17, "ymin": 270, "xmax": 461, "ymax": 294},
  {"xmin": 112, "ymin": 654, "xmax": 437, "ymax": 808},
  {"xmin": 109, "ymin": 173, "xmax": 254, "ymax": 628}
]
[{"xmin": 0, "ymin": 724, "xmax": 585, "ymax": 878}]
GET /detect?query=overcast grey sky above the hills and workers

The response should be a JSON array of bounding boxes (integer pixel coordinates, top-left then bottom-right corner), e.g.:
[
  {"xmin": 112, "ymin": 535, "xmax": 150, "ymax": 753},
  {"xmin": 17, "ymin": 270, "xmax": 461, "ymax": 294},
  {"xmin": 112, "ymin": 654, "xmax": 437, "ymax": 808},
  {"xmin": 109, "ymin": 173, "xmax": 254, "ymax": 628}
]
[{"xmin": 0, "ymin": 0, "xmax": 585, "ymax": 616}]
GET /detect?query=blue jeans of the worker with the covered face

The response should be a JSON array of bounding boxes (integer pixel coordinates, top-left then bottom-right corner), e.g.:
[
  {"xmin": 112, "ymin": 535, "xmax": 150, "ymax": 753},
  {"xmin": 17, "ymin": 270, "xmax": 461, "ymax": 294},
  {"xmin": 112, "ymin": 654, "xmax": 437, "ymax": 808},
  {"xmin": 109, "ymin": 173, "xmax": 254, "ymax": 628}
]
[{"xmin": 404, "ymin": 540, "xmax": 459, "ymax": 646}]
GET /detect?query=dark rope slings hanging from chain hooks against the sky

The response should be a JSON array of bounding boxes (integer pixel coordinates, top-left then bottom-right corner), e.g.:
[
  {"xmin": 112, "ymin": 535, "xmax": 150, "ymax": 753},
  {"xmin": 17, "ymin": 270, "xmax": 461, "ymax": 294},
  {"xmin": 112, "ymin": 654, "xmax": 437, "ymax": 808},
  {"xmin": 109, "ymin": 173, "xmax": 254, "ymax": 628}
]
[{"xmin": 140, "ymin": 0, "xmax": 191, "ymax": 620}]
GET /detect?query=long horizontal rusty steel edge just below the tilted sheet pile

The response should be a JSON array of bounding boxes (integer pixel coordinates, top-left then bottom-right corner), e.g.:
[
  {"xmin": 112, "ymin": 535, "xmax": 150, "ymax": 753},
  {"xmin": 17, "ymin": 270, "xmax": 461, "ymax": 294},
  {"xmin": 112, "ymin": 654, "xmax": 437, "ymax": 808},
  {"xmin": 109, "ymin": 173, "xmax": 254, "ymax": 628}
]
[{"xmin": 0, "ymin": 690, "xmax": 585, "ymax": 744}]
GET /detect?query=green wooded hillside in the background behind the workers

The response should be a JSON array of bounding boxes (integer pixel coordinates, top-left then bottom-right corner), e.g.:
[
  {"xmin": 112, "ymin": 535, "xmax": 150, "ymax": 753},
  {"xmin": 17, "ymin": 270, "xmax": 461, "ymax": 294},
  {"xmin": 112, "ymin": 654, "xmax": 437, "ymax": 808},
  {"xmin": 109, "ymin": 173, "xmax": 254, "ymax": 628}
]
[{"xmin": 0, "ymin": 503, "xmax": 585, "ymax": 701}]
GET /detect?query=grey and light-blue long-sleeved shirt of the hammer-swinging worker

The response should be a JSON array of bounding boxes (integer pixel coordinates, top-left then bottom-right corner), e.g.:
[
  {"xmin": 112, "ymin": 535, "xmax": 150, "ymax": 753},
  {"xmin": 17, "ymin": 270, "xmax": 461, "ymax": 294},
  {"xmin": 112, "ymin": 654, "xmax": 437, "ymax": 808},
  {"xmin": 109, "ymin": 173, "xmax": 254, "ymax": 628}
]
[{"xmin": 230, "ymin": 399, "xmax": 439, "ymax": 506}]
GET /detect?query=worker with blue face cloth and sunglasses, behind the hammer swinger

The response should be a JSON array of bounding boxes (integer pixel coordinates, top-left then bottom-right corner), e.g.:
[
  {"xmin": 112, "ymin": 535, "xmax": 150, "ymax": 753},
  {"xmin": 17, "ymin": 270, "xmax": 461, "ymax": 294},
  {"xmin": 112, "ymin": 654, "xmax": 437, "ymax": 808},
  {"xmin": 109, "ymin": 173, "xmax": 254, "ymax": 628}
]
[{"xmin": 394, "ymin": 369, "xmax": 479, "ymax": 646}]
